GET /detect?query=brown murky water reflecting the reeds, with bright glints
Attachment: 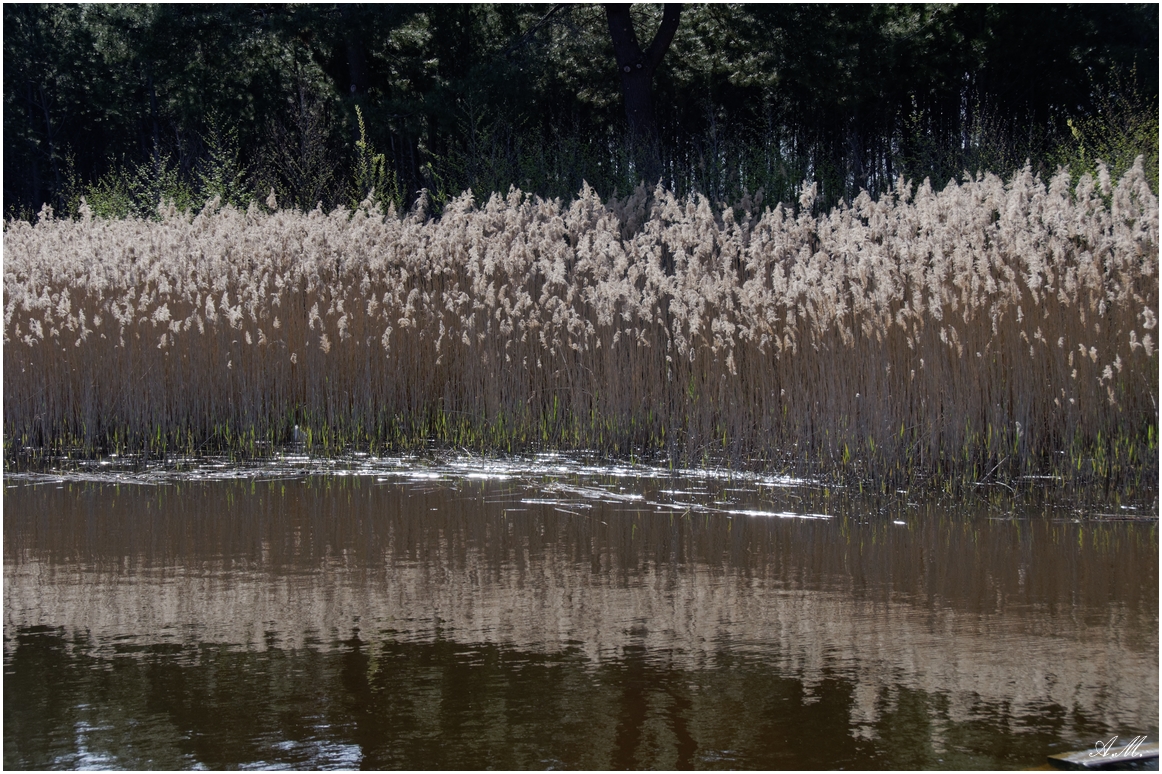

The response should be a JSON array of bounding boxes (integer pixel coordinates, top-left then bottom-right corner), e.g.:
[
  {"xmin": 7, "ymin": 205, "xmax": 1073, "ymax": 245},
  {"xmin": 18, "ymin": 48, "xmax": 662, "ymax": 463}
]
[{"xmin": 3, "ymin": 458, "xmax": 1159, "ymax": 769}]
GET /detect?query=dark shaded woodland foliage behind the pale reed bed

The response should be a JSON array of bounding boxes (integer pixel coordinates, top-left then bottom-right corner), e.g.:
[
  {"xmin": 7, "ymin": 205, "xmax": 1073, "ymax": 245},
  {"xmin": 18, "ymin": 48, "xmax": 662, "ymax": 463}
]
[{"xmin": 3, "ymin": 3, "xmax": 1159, "ymax": 218}]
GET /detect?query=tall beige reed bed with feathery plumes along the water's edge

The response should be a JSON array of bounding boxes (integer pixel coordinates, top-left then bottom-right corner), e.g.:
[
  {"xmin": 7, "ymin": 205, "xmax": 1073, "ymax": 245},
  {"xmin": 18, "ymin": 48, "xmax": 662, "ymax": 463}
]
[{"xmin": 3, "ymin": 159, "xmax": 1159, "ymax": 490}]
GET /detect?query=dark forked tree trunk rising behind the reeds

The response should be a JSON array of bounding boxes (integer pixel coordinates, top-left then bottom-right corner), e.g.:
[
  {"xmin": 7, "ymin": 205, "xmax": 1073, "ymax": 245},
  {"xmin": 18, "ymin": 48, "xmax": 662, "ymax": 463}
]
[{"xmin": 605, "ymin": 2, "xmax": 682, "ymax": 182}]
